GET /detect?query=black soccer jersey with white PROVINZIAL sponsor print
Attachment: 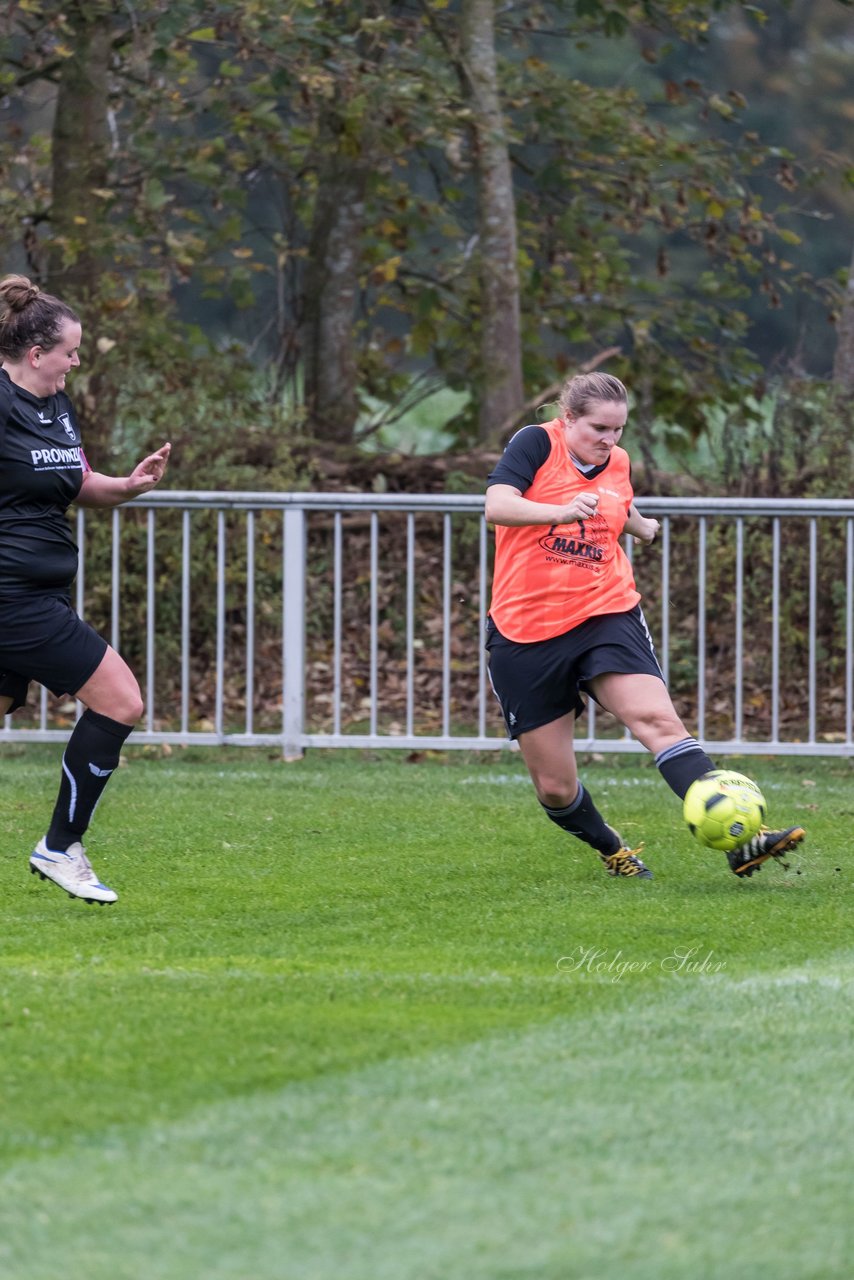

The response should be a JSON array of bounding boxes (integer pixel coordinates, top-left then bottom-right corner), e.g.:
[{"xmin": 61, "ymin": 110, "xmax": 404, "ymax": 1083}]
[{"xmin": 0, "ymin": 369, "xmax": 90, "ymax": 596}]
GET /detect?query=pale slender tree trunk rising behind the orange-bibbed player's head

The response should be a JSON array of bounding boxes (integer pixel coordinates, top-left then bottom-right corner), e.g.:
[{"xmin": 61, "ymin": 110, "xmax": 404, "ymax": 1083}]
[{"xmin": 461, "ymin": 0, "xmax": 525, "ymax": 440}]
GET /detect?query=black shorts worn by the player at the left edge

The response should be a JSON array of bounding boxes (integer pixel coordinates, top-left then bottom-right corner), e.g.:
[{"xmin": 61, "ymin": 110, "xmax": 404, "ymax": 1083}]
[{"xmin": 0, "ymin": 591, "xmax": 109, "ymax": 710}]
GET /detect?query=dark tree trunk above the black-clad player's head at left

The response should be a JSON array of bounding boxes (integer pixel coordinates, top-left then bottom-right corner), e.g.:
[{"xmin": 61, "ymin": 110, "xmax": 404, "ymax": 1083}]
[{"xmin": 49, "ymin": 0, "xmax": 113, "ymax": 298}]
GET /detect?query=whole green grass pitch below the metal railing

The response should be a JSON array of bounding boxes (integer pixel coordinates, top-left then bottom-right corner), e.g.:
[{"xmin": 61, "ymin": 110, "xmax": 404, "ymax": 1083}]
[{"xmin": 0, "ymin": 746, "xmax": 854, "ymax": 1280}]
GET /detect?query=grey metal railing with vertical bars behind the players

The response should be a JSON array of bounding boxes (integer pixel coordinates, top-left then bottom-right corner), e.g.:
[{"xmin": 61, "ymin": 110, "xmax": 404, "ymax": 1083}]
[{"xmin": 0, "ymin": 490, "xmax": 854, "ymax": 758}]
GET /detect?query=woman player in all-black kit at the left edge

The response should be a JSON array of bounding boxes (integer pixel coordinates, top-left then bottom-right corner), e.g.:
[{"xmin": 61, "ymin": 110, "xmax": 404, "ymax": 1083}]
[{"xmin": 0, "ymin": 275, "xmax": 170, "ymax": 904}]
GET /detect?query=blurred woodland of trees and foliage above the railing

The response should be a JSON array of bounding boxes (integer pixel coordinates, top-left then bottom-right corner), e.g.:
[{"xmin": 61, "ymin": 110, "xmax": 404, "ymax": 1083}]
[{"xmin": 0, "ymin": 0, "xmax": 854, "ymax": 488}]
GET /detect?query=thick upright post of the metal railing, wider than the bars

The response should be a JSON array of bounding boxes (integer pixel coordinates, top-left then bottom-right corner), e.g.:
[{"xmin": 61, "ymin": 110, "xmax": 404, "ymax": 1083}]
[{"xmin": 282, "ymin": 507, "xmax": 306, "ymax": 760}]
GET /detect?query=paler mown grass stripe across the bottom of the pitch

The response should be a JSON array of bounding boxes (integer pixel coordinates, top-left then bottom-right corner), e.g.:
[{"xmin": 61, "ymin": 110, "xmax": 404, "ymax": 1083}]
[{"xmin": 0, "ymin": 955, "xmax": 854, "ymax": 1280}]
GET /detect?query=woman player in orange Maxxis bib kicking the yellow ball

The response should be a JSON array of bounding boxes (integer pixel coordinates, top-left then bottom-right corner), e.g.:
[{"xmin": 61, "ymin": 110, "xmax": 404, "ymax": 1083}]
[{"xmin": 487, "ymin": 374, "xmax": 804, "ymax": 879}]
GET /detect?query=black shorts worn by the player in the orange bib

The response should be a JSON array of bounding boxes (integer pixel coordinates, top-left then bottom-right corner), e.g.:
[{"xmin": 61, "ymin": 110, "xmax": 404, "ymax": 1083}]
[{"xmin": 487, "ymin": 604, "xmax": 665, "ymax": 737}]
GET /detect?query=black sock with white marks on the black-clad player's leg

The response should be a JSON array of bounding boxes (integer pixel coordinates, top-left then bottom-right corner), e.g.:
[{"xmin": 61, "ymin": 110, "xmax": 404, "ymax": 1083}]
[{"xmin": 45, "ymin": 708, "xmax": 133, "ymax": 852}]
